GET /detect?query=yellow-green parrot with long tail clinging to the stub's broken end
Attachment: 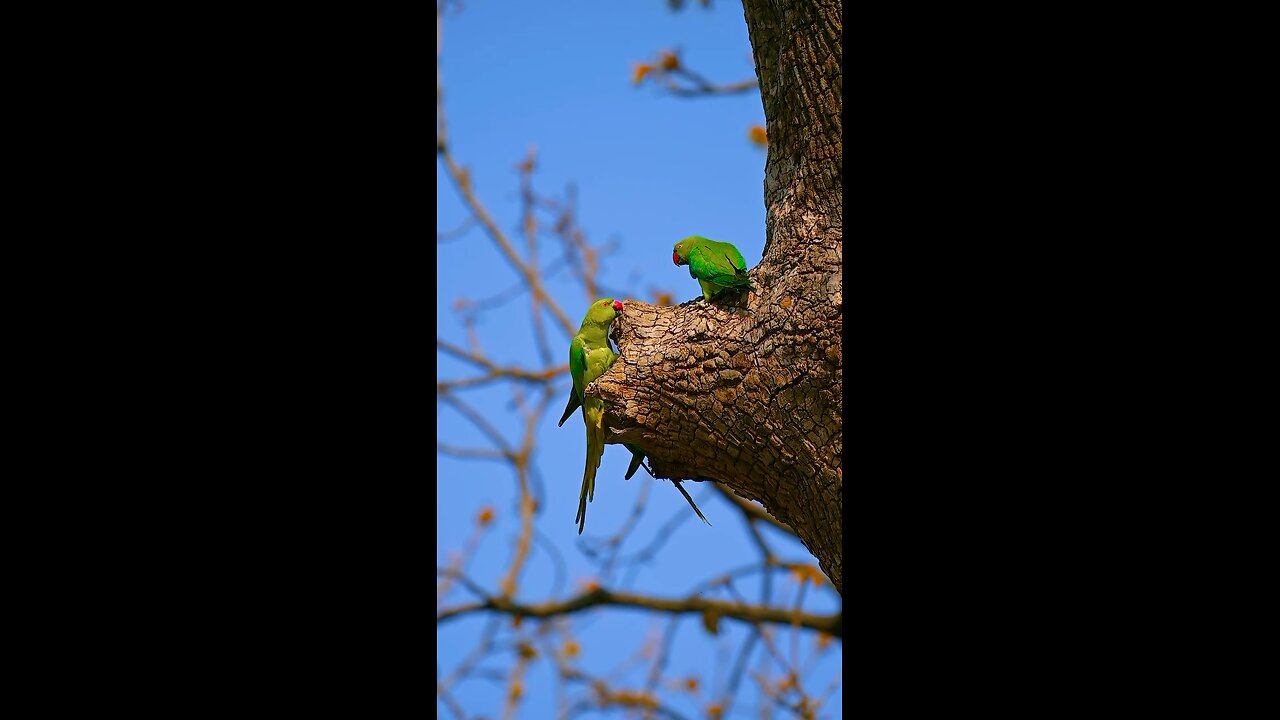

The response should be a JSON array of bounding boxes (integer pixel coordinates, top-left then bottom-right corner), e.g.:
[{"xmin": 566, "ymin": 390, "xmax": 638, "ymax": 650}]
[{"xmin": 557, "ymin": 297, "xmax": 710, "ymax": 534}]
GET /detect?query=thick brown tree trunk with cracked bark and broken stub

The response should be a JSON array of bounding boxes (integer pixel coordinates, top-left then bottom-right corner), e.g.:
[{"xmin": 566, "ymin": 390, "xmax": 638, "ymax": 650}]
[{"xmin": 588, "ymin": 0, "xmax": 844, "ymax": 594}]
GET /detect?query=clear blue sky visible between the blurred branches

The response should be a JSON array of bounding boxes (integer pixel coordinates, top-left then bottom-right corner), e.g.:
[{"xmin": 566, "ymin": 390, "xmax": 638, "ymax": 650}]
[{"xmin": 440, "ymin": 0, "xmax": 842, "ymax": 717}]
